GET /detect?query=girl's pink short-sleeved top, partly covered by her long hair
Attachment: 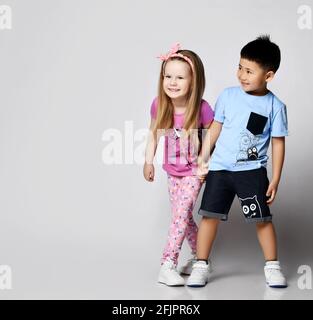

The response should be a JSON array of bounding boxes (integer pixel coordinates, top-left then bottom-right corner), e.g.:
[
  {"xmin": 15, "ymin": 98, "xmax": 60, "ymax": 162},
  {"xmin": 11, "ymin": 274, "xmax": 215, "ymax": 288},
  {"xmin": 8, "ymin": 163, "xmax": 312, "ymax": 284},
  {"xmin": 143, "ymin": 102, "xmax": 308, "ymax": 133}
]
[{"xmin": 150, "ymin": 98, "xmax": 214, "ymax": 176}]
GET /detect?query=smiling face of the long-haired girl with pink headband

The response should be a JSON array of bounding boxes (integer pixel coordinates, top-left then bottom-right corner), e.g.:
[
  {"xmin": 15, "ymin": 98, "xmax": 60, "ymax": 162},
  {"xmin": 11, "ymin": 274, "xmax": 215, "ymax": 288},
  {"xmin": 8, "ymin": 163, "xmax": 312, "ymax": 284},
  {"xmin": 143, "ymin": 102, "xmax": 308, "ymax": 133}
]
[{"xmin": 163, "ymin": 60, "xmax": 191, "ymax": 101}]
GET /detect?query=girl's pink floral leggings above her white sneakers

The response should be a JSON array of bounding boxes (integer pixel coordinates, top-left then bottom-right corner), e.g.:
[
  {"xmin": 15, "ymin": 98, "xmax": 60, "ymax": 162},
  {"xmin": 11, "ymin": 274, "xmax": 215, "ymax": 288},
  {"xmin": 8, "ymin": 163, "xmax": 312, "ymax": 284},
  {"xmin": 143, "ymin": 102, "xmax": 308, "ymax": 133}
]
[{"xmin": 161, "ymin": 174, "xmax": 202, "ymax": 265}]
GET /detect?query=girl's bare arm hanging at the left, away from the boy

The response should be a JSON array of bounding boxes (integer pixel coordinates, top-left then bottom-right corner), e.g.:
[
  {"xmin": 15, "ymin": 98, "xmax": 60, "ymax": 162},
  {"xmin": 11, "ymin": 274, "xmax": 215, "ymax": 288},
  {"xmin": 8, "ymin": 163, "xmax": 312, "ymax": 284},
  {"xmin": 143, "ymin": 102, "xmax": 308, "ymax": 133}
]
[{"xmin": 143, "ymin": 119, "xmax": 160, "ymax": 182}]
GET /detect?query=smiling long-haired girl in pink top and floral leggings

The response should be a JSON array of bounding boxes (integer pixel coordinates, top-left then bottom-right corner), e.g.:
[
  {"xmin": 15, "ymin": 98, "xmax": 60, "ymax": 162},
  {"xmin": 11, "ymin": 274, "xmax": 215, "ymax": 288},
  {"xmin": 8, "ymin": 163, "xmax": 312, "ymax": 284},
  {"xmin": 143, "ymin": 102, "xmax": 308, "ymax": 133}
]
[{"xmin": 143, "ymin": 44, "xmax": 213, "ymax": 286}]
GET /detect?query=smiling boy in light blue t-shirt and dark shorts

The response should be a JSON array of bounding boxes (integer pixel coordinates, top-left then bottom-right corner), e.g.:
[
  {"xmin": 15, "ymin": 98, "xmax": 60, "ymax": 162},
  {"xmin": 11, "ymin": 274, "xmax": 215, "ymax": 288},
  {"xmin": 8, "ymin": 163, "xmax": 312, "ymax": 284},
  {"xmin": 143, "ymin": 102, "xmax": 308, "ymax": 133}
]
[{"xmin": 187, "ymin": 36, "xmax": 288, "ymax": 288}]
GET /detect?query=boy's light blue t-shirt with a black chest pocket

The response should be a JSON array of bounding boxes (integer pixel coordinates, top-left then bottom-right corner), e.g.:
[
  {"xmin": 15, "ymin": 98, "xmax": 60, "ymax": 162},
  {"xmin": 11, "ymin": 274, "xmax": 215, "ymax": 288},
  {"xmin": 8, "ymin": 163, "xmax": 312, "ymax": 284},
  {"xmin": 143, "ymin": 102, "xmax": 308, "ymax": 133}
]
[{"xmin": 209, "ymin": 87, "xmax": 288, "ymax": 171}]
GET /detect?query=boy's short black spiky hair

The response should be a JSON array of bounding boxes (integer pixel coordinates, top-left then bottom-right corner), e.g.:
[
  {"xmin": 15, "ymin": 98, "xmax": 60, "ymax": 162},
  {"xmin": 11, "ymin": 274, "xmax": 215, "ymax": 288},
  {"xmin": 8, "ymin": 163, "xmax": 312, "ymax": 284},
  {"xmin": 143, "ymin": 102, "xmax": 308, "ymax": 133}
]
[{"xmin": 240, "ymin": 35, "xmax": 280, "ymax": 73}]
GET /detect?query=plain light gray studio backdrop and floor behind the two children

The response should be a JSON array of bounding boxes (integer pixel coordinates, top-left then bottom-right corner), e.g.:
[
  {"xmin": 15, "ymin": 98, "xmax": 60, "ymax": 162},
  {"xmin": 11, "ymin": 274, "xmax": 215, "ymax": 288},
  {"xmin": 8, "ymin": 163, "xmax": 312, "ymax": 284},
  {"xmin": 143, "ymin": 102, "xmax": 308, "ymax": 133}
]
[{"xmin": 0, "ymin": 0, "xmax": 313, "ymax": 299}]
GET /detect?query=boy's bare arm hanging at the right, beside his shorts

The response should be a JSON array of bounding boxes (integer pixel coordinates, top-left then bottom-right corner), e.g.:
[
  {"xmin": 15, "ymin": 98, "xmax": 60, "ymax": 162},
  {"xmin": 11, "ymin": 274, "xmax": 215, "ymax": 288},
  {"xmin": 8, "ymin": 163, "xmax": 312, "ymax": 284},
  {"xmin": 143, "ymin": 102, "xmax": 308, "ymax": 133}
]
[{"xmin": 266, "ymin": 137, "xmax": 285, "ymax": 204}]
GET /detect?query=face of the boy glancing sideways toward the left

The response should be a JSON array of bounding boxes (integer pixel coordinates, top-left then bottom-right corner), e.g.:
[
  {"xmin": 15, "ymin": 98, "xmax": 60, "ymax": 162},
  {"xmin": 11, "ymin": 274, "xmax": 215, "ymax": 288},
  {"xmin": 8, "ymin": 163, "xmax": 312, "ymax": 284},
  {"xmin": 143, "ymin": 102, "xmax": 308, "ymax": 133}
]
[{"xmin": 237, "ymin": 58, "xmax": 274, "ymax": 95}]
